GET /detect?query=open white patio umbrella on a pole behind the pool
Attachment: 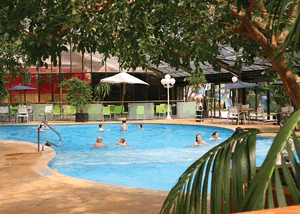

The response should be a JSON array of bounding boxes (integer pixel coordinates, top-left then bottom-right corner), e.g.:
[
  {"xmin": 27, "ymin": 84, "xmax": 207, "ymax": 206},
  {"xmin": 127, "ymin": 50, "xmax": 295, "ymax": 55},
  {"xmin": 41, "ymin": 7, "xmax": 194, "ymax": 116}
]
[{"xmin": 100, "ymin": 72, "xmax": 149, "ymax": 114}]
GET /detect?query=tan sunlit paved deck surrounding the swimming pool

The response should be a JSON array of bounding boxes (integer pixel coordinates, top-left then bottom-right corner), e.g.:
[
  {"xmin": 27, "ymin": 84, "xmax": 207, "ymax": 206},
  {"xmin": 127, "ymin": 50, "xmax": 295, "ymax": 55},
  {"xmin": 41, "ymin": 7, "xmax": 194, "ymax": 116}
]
[{"xmin": 0, "ymin": 119, "xmax": 300, "ymax": 214}]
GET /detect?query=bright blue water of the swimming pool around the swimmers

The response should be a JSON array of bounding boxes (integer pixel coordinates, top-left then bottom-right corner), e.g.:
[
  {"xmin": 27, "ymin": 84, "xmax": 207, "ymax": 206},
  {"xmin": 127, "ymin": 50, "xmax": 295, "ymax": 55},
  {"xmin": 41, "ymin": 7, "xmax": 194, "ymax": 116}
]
[{"xmin": 0, "ymin": 124, "xmax": 273, "ymax": 190}]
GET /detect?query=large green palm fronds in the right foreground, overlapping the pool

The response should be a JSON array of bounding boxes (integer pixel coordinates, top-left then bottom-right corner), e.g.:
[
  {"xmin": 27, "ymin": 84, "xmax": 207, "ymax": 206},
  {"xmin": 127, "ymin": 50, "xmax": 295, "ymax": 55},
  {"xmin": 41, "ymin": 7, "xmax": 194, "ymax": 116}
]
[{"xmin": 160, "ymin": 109, "xmax": 300, "ymax": 214}]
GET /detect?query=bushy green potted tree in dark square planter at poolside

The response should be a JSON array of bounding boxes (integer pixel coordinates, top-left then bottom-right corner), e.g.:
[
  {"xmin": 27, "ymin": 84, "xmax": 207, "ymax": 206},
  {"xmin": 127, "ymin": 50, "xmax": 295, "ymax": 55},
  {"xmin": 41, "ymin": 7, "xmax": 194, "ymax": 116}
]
[{"xmin": 61, "ymin": 77, "xmax": 92, "ymax": 122}]
